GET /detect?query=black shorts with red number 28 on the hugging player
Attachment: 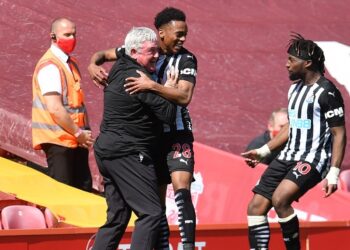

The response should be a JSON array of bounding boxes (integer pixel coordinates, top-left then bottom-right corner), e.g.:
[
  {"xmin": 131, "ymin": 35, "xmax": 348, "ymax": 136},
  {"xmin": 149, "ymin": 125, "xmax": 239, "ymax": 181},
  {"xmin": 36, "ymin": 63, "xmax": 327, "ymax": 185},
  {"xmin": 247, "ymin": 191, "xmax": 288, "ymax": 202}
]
[{"xmin": 157, "ymin": 132, "xmax": 194, "ymax": 184}]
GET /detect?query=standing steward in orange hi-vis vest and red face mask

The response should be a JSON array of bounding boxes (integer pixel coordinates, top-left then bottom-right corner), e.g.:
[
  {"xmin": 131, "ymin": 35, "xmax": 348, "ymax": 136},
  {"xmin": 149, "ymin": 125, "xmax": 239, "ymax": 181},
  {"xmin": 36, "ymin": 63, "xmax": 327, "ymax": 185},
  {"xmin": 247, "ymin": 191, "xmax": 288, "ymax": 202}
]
[{"xmin": 32, "ymin": 17, "xmax": 95, "ymax": 191}]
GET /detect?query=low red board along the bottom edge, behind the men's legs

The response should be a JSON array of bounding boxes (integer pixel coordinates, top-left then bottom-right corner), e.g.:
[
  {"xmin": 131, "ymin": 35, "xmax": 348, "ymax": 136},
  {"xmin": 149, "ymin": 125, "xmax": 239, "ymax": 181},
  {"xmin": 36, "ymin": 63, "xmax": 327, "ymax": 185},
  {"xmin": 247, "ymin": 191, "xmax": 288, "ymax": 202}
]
[{"xmin": 0, "ymin": 221, "xmax": 350, "ymax": 250}]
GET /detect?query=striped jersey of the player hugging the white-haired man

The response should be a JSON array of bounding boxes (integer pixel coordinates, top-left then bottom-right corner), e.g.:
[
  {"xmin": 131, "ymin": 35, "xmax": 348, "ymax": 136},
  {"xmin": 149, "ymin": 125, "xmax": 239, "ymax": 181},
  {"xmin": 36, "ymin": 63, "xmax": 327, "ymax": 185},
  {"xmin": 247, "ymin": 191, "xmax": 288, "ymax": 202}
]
[{"xmin": 156, "ymin": 48, "xmax": 197, "ymax": 133}]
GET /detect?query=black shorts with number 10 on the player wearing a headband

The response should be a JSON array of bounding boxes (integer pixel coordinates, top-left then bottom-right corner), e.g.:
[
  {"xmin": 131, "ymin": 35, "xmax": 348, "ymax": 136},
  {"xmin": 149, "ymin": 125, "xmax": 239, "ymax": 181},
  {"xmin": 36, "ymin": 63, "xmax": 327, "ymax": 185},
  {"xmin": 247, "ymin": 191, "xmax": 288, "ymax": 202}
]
[{"xmin": 253, "ymin": 159, "xmax": 322, "ymax": 200}]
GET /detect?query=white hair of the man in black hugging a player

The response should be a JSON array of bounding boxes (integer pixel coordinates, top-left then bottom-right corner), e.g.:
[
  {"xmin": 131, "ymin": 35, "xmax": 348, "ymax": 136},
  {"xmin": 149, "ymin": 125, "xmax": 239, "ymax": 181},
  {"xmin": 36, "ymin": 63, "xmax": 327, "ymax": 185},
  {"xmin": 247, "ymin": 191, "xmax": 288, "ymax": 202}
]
[{"xmin": 124, "ymin": 27, "xmax": 157, "ymax": 56}]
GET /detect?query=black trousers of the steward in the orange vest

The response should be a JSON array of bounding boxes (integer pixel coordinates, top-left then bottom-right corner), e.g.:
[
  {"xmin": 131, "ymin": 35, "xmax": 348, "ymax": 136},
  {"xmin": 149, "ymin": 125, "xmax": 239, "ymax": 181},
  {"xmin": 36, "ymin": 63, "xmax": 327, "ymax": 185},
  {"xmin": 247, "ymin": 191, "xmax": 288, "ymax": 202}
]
[{"xmin": 41, "ymin": 143, "xmax": 92, "ymax": 192}]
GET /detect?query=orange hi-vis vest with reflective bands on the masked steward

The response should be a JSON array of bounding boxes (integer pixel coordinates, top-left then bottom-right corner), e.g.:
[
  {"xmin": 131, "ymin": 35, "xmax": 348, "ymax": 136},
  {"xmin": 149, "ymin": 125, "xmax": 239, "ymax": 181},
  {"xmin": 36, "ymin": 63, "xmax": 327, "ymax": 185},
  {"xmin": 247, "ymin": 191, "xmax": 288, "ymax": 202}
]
[{"xmin": 32, "ymin": 49, "xmax": 88, "ymax": 149}]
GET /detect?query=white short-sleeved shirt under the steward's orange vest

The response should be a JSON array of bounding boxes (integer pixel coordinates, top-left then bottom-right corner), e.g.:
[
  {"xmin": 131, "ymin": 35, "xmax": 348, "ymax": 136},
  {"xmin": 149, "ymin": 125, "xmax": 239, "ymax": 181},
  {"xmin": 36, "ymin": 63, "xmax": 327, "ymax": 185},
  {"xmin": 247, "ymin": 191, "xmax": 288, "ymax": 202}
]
[{"xmin": 38, "ymin": 45, "xmax": 70, "ymax": 95}]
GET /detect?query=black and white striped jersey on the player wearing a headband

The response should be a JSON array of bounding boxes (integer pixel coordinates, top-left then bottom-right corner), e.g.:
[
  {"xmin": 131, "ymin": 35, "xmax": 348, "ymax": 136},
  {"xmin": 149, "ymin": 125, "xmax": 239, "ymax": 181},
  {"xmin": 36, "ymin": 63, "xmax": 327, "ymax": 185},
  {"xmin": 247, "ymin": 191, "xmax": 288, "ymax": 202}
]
[{"xmin": 278, "ymin": 77, "xmax": 345, "ymax": 174}]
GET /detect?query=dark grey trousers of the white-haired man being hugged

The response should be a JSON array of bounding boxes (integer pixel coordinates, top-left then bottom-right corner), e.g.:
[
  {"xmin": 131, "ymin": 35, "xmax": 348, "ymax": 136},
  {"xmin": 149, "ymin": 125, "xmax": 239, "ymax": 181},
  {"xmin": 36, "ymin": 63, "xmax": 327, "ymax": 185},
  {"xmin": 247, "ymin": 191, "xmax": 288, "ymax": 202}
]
[{"xmin": 93, "ymin": 153, "xmax": 162, "ymax": 250}]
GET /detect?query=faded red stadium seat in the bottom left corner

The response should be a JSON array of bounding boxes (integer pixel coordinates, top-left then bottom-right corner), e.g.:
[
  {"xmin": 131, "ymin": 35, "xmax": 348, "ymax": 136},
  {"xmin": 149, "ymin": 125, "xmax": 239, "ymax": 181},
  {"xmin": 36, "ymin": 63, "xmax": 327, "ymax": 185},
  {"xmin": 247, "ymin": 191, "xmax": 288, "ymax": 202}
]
[{"xmin": 1, "ymin": 205, "xmax": 46, "ymax": 229}]
